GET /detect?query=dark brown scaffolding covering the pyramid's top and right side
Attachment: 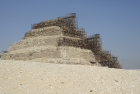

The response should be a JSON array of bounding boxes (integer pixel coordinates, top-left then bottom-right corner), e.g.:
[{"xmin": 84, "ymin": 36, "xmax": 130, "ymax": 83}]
[{"xmin": 31, "ymin": 13, "xmax": 121, "ymax": 69}]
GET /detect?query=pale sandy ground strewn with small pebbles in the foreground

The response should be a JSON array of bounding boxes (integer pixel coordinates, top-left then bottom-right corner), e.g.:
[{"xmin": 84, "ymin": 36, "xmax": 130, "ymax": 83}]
[{"xmin": 0, "ymin": 60, "xmax": 140, "ymax": 94}]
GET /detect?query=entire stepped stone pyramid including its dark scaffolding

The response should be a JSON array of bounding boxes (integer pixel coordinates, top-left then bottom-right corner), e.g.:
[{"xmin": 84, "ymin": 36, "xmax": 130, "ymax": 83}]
[{"xmin": 1, "ymin": 13, "xmax": 121, "ymax": 68}]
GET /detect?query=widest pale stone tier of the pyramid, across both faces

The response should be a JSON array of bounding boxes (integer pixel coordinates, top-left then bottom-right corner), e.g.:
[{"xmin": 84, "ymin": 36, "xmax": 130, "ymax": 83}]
[{"xmin": 1, "ymin": 46, "xmax": 95, "ymax": 62}]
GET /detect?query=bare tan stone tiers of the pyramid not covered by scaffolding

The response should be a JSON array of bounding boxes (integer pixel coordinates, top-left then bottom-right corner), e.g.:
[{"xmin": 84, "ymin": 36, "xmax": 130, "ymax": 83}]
[{"xmin": 1, "ymin": 26, "xmax": 95, "ymax": 64}]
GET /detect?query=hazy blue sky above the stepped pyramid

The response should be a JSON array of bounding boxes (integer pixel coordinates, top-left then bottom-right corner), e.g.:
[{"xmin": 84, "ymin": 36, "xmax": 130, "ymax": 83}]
[{"xmin": 0, "ymin": 0, "xmax": 140, "ymax": 69}]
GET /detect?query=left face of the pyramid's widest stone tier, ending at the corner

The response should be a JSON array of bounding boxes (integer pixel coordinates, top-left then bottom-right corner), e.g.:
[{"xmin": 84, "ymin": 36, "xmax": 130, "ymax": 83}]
[{"xmin": 2, "ymin": 46, "xmax": 57, "ymax": 60}]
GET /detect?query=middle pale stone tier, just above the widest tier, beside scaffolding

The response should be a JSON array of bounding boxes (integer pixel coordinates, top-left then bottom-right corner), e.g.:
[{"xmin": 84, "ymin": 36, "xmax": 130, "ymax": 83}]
[{"xmin": 7, "ymin": 35, "xmax": 80, "ymax": 52}]
